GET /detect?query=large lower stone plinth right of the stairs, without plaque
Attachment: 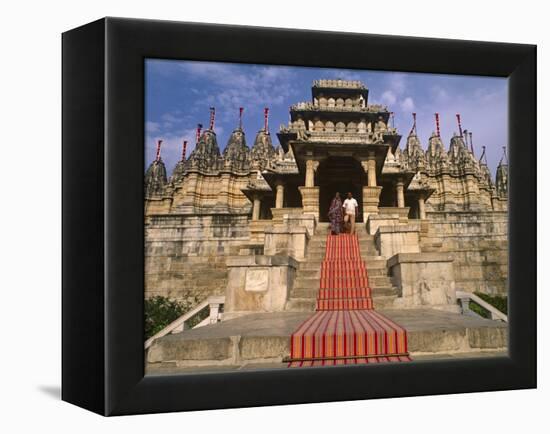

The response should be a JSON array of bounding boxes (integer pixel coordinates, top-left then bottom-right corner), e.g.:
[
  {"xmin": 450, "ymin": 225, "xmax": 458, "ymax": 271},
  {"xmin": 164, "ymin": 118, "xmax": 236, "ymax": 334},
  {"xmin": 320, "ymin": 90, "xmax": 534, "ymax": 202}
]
[{"xmin": 388, "ymin": 253, "xmax": 460, "ymax": 312}]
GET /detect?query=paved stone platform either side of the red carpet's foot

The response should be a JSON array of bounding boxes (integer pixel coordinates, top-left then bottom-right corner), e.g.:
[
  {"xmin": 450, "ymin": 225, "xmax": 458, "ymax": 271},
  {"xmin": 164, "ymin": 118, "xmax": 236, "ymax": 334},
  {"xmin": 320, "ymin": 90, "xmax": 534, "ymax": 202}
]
[{"xmin": 147, "ymin": 309, "xmax": 508, "ymax": 373}]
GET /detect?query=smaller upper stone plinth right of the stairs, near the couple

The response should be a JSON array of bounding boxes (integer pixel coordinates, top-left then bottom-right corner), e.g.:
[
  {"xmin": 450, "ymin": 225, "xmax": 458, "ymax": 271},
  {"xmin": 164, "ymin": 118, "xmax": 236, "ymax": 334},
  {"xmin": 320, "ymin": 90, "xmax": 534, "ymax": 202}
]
[{"xmin": 374, "ymin": 224, "xmax": 420, "ymax": 258}]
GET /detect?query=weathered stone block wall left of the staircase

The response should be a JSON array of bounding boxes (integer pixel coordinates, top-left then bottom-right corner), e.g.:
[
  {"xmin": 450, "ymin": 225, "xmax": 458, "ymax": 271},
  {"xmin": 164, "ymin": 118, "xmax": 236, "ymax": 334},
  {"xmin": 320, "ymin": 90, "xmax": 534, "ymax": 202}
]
[{"xmin": 145, "ymin": 214, "xmax": 250, "ymax": 301}]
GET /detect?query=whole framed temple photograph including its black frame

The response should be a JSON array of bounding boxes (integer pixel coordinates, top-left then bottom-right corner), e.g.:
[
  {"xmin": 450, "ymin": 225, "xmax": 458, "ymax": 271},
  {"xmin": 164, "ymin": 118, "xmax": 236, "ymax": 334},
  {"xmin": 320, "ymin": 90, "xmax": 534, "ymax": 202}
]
[{"xmin": 62, "ymin": 18, "xmax": 536, "ymax": 415}]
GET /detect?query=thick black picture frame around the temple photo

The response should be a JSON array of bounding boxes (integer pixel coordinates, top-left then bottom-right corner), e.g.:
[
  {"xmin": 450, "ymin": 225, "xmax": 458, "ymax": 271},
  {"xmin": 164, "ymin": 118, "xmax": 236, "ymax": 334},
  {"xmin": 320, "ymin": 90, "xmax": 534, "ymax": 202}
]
[{"xmin": 62, "ymin": 18, "xmax": 536, "ymax": 415}]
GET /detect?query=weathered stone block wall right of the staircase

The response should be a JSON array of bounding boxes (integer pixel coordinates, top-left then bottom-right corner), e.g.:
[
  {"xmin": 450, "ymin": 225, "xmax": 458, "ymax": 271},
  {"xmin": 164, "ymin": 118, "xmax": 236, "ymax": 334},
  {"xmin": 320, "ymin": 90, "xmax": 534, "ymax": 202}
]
[{"xmin": 421, "ymin": 211, "xmax": 508, "ymax": 295}]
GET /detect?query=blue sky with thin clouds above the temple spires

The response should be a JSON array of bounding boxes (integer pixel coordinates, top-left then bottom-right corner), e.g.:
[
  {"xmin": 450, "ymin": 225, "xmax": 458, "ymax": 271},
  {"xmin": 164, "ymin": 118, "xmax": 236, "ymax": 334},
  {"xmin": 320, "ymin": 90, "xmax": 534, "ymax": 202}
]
[{"xmin": 145, "ymin": 59, "xmax": 508, "ymax": 177}]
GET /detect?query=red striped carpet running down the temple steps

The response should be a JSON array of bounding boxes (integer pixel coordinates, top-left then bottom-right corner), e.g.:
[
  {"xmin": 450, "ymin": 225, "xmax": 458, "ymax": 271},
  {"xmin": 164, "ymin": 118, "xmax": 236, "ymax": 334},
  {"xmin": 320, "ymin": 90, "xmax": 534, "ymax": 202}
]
[{"xmin": 288, "ymin": 234, "xmax": 411, "ymax": 367}]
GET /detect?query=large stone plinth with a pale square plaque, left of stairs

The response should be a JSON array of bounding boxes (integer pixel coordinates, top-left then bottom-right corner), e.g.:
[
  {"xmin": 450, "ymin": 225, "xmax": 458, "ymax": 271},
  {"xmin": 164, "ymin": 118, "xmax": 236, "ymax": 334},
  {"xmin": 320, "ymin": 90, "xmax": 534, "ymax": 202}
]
[{"xmin": 224, "ymin": 255, "xmax": 298, "ymax": 318}]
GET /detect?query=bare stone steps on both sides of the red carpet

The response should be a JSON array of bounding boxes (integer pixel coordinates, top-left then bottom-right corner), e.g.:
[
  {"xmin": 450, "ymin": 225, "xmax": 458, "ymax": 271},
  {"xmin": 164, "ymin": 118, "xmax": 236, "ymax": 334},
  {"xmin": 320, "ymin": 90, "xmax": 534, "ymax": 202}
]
[{"xmin": 286, "ymin": 223, "xmax": 397, "ymax": 312}]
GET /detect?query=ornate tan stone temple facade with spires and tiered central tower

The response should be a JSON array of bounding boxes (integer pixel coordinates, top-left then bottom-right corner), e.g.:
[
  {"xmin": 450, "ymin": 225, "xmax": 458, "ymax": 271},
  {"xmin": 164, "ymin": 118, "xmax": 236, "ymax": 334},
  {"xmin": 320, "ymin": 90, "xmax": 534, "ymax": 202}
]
[{"xmin": 145, "ymin": 80, "xmax": 508, "ymax": 313}]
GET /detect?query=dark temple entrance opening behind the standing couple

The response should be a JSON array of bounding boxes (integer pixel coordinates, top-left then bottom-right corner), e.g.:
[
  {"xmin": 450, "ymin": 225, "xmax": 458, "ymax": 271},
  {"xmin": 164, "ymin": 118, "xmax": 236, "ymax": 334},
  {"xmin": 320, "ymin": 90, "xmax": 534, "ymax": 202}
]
[{"xmin": 315, "ymin": 157, "xmax": 367, "ymax": 222}]
